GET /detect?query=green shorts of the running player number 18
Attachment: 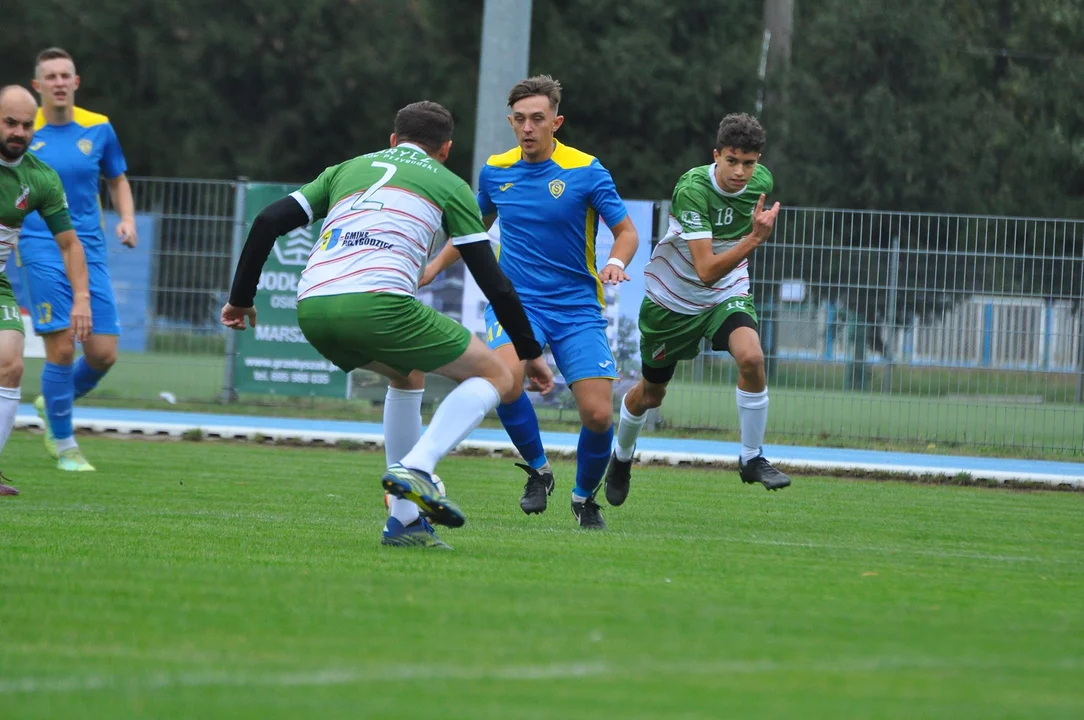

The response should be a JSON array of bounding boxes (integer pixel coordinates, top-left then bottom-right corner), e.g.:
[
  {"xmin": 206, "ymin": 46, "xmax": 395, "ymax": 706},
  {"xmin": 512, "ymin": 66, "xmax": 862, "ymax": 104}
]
[{"xmin": 640, "ymin": 295, "xmax": 757, "ymax": 368}]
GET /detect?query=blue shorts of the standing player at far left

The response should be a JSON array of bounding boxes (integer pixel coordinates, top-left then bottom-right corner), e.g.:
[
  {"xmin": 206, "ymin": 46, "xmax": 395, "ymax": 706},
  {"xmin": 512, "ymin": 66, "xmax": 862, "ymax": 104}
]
[{"xmin": 22, "ymin": 262, "xmax": 120, "ymax": 335}]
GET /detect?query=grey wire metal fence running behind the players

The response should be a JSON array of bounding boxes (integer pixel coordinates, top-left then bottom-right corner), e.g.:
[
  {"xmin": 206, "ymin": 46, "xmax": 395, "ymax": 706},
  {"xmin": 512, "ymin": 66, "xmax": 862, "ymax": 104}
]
[{"xmin": 80, "ymin": 178, "xmax": 1084, "ymax": 452}]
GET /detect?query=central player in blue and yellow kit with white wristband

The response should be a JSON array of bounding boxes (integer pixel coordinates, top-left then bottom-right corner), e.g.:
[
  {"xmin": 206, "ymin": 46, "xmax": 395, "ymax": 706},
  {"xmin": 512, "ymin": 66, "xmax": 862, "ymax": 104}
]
[{"xmin": 423, "ymin": 75, "xmax": 640, "ymax": 529}]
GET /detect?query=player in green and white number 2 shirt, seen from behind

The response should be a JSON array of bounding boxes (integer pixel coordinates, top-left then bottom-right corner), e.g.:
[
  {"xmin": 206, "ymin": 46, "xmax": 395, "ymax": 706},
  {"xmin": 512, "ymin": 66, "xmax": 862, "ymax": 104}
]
[{"xmin": 222, "ymin": 102, "xmax": 553, "ymax": 548}]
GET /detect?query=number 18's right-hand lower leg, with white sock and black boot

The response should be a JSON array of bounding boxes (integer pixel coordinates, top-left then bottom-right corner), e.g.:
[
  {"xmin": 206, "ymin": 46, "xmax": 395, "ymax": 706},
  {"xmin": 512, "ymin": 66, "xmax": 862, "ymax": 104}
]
[{"xmin": 728, "ymin": 326, "xmax": 790, "ymax": 490}]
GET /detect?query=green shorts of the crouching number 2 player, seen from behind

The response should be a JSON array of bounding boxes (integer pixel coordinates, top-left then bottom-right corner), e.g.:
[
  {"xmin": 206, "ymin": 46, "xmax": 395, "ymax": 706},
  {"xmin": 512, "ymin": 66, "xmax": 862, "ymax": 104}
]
[{"xmin": 297, "ymin": 293, "xmax": 470, "ymax": 375}]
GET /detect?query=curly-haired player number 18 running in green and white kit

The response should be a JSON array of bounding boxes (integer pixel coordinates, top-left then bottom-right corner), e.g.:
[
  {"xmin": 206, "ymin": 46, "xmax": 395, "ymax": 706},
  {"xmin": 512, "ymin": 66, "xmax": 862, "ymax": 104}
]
[{"xmin": 606, "ymin": 114, "xmax": 790, "ymax": 505}]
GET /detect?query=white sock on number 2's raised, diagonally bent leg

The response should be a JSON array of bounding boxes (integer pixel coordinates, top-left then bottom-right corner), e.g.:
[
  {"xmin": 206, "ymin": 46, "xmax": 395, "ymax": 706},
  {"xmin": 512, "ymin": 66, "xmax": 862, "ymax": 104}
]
[{"xmin": 399, "ymin": 377, "xmax": 501, "ymax": 474}]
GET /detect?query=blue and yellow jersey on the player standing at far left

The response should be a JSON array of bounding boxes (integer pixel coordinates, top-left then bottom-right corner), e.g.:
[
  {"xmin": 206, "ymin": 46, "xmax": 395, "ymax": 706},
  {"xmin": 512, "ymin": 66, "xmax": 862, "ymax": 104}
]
[{"xmin": 16, "ymin": 107, "xmax": 128, "ymax": 266}]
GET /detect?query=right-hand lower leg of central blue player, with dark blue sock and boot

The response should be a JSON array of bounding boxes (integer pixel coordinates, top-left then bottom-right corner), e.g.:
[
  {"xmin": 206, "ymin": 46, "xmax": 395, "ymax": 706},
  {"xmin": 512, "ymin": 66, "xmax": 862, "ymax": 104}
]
[{"xmin": 571, "ymin": 377, "xmax": 614, "ymax": 530}]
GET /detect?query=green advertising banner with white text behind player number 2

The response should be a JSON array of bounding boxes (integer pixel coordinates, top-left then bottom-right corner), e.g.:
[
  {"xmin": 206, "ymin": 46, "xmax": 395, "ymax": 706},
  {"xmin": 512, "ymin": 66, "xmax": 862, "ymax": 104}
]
[{"xmin": 233, "ymin": 182, "xmax": 348, "ymax": 398}]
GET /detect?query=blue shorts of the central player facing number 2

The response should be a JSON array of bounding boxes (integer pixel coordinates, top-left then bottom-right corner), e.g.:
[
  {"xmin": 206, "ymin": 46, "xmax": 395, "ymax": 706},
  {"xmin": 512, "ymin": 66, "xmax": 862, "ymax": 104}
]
[{"xmin": 486, "ymin": 305, "xmax": 617, "ymax": 385}]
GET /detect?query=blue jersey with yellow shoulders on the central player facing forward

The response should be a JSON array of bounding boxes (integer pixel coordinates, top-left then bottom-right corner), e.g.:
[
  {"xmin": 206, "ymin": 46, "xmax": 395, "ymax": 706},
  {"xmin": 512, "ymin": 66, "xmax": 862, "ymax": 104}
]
[{"xmin": 478, "ymin": 142, "xmax": 628, "ymax": 310}]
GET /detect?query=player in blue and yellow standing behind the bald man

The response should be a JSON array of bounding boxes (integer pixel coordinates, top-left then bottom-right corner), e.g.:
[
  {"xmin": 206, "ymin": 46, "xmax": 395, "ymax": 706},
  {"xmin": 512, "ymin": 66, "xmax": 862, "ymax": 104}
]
[{"xmin": 16, "ymin": 48, "xmax": 137, "ymax": 471}]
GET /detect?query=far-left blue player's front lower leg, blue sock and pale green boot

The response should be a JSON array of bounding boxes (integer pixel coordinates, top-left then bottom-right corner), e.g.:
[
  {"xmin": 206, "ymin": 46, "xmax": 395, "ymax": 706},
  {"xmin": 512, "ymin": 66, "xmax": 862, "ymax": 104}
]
[{"xmin": 34, "ymin": 329, "xmax": 94, "ymax": 472}]
